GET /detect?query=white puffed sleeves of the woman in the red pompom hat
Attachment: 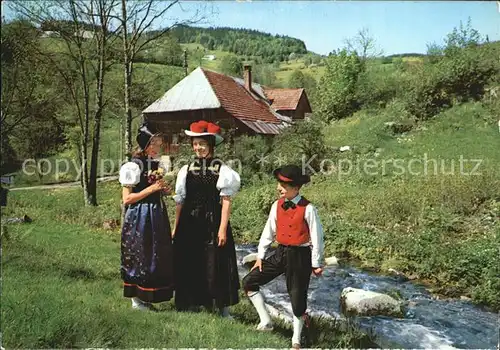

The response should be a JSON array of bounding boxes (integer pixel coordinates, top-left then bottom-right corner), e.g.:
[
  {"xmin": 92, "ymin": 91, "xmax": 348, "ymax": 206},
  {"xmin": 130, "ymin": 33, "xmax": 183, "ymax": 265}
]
[{"xmin": 173, "ymin": 164, "xmax": 241, "ymax": 204}]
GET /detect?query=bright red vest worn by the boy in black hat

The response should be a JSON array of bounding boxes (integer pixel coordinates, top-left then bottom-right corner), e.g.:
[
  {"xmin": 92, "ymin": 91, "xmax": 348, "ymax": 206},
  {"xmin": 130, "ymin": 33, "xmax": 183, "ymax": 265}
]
[{"xmin": 276, "ymin": 197, "xmax": 310, "ymax": 246}]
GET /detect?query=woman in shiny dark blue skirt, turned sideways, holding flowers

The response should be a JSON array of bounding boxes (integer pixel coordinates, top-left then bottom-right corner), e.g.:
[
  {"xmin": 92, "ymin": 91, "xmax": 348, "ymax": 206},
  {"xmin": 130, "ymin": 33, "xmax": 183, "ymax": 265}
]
[{"xmin": 119, "ymin": 124, "xmax": 174, "ymax": 310}]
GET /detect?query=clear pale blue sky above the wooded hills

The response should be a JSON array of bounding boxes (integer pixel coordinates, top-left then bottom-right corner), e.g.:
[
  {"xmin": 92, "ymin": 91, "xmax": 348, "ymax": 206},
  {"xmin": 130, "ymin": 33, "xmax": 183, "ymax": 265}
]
[{"xmin": 3, "ymin": 0, "xmax": 500, "ymax": 55}]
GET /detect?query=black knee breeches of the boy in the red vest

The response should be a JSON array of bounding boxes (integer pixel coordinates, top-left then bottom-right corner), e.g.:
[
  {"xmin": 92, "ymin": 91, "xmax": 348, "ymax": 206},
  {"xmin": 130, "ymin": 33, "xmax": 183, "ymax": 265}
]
[{"xmin": 243, "ymin": 245, "xmax": 312, "ymax": 317}]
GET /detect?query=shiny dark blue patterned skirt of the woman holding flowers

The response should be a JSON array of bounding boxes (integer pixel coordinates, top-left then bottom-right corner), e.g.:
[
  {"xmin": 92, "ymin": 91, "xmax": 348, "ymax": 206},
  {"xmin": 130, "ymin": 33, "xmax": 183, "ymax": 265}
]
[{"xmin": 121, "ymin": 201, "xmax": 174, "ymax": 303}]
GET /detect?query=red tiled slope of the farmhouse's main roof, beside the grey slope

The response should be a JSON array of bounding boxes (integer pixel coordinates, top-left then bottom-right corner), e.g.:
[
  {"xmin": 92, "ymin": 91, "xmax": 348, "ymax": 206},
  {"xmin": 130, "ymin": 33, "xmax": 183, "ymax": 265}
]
[{"xmin": 202, "ymin": 68, "xmax": 281, "ymax": 124}]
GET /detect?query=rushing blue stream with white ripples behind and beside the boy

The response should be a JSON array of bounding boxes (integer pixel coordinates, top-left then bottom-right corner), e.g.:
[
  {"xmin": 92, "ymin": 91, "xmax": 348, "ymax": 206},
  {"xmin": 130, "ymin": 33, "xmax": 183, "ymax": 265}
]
[{"xmin": 236, "ymin": 245, "xmax": 500, "ymax": 349}]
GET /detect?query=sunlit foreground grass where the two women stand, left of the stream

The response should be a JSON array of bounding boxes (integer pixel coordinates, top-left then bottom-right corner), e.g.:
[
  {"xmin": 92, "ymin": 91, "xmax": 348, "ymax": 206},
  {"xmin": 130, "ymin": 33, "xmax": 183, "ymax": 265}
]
[{"xmin": 2, "ymin": 218, "xmax": 287, "ymax": 348}]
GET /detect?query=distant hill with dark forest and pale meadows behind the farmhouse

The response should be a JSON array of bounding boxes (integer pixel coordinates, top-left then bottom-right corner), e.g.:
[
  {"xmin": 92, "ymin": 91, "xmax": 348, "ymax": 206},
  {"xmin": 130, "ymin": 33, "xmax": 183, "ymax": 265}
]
[{"xmin": 37, "ymin": 26, "xmax": 422, "ymax": 92}]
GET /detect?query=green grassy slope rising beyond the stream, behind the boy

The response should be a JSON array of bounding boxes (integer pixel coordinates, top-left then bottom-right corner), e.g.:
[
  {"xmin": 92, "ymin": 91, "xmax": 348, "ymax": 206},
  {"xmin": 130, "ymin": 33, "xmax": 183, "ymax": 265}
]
[{"xmin": 233, "ymin": 102, "xmax": 500, "ymax": 310}]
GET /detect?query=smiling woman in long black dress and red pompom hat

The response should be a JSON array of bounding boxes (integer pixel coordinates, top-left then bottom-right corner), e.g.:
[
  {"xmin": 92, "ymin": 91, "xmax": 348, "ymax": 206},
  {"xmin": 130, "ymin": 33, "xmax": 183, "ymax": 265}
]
[{"xmin": 173, "ymin": 121, "xmax": 240, "ymax": 318}]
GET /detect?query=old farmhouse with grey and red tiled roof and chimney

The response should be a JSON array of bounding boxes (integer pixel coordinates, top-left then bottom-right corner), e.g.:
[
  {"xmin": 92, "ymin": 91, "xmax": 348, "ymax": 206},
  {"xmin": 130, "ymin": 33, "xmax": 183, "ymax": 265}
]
[{"xmin": 142, "ymin": 66, "xmax": 311, "ymax": 150}]
